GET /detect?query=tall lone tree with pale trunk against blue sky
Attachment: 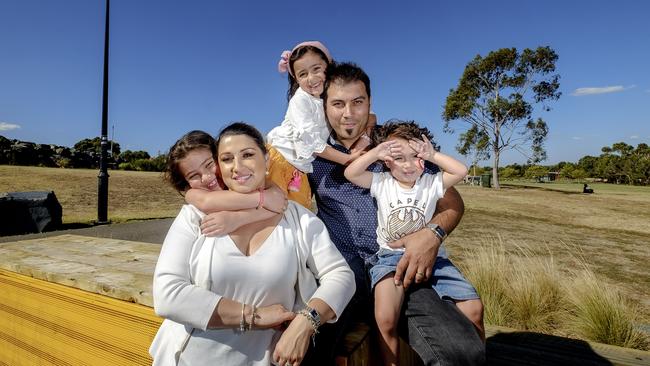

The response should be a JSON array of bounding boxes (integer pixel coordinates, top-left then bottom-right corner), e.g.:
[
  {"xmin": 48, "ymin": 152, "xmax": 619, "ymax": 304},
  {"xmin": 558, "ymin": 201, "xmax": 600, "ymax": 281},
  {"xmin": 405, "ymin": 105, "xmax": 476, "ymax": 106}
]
[{"xmin": 442, "ymin": 47, "xmax": 561, "ymax": 188}]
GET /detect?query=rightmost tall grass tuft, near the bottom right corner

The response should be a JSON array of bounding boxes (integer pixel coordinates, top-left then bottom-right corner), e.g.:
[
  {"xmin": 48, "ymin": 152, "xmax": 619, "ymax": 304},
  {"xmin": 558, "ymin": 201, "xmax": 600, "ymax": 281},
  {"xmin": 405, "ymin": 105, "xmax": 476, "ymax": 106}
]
[{"xmin": 566, "ymin": 269, "xmax": 649, "ymax": 349}]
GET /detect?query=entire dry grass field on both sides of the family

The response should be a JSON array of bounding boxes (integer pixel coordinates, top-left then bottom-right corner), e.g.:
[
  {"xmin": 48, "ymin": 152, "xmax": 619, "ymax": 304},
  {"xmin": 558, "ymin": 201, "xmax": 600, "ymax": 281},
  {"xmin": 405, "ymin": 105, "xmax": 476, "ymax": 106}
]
[{"xmin": 0, "ymin": 166, "xmax": 650, "ymax": 323}]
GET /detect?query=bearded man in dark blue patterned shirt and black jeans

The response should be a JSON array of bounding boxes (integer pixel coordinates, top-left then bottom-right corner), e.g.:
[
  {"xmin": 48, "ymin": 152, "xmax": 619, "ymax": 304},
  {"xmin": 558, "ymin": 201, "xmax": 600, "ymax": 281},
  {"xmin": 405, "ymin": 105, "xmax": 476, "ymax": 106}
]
[{"xmin": 309, "ymin": 64, "xmax": 485, "ymax": 365}]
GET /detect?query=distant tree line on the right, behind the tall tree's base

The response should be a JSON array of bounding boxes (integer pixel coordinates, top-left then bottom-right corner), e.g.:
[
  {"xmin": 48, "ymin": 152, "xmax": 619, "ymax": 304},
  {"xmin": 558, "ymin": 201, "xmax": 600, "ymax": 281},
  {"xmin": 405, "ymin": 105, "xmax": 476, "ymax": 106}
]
[{"xmin": 470, "ymin": 142, "xmax": 650, "ymax": 186}]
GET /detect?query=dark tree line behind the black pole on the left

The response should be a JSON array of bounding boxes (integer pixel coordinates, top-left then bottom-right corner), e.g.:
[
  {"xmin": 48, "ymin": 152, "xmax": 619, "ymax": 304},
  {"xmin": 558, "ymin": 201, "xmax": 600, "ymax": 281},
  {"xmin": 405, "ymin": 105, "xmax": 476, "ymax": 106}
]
[{"xmin": 0, "ymin": 135, "xmax": 166, "ymax": 171}]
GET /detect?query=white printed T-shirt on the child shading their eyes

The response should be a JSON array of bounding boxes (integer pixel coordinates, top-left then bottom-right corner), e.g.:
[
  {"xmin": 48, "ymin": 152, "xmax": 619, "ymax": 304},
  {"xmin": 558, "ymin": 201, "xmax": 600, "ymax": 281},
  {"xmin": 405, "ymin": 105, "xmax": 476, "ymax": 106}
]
[{"xmin": 370, "ymin": 172, "xmax": 445, "ymax": 251}]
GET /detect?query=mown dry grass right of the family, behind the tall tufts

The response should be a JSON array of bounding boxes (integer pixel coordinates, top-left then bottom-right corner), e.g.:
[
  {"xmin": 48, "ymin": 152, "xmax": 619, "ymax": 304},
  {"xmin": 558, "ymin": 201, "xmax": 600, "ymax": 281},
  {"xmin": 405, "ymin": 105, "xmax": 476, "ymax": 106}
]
[{"xmin": 447, "ymin": 184, "xmax": 650, "ymax": 323}]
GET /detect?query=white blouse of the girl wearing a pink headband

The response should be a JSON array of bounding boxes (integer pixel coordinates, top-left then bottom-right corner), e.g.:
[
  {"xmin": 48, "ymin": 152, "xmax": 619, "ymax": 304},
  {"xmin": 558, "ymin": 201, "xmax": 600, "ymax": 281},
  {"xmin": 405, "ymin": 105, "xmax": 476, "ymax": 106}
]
[{"xmin": 266, "ymin": 88, "xmax": 330, "ymax": 173}]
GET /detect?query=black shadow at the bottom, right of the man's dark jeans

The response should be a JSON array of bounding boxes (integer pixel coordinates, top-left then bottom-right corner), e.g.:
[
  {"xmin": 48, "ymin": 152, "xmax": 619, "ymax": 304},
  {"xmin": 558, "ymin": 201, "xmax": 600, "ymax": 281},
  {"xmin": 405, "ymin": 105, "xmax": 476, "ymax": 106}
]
[{"xmin": 486, "ymin": 331, "xmax": 612, "ymax": 366}]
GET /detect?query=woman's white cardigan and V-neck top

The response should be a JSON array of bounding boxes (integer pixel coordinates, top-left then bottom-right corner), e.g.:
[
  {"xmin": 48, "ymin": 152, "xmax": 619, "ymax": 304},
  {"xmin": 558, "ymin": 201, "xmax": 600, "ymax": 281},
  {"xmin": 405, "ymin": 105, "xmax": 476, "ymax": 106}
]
[{"xmin": 149, "ymin": 201, "xmax": 355, "ymax": 365}]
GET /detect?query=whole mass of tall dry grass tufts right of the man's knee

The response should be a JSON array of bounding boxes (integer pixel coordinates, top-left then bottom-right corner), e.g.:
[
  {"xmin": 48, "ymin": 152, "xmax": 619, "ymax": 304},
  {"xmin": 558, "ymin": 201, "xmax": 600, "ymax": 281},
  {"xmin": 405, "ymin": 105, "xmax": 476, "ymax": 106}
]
[{"xmin": 459, "ymin": 237, "xmax": 649, "ymax": 349}]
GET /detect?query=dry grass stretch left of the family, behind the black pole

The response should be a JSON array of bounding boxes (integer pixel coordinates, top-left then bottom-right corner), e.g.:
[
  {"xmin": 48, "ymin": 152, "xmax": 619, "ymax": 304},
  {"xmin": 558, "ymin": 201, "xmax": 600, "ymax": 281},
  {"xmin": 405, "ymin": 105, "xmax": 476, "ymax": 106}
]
[{"xmin": 0, "ymin": 165, "xmax": 183, "ymax": 224}]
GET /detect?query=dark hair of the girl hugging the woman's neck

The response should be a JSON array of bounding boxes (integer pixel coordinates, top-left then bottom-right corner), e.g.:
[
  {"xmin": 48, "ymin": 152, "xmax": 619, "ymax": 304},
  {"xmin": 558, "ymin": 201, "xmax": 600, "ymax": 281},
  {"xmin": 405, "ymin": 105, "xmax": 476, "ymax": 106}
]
[{"xmin": 163, "ymin": 130, "xmax": 217, "ymax": 193}]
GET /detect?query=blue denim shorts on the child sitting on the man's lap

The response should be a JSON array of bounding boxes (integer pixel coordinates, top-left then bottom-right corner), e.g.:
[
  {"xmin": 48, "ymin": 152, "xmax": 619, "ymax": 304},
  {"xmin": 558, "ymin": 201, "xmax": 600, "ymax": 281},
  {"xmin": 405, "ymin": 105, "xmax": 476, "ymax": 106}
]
[{"xmin": 366, "ymin": 245, "xmax": 479, "ymax": 301}]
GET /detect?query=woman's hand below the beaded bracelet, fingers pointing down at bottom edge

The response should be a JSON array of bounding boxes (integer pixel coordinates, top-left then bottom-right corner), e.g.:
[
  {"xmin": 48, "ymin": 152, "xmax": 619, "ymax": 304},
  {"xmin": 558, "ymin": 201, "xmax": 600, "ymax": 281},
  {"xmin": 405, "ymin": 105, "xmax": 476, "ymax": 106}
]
[{"xmin": 273, "ymin": 315, "xmax": 314, "ymax": 366}]
